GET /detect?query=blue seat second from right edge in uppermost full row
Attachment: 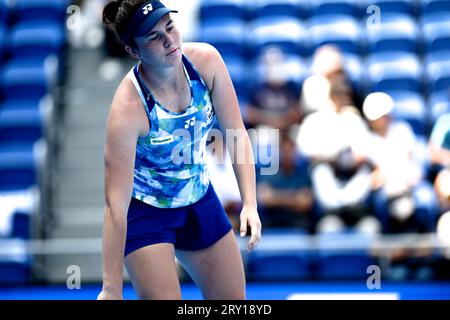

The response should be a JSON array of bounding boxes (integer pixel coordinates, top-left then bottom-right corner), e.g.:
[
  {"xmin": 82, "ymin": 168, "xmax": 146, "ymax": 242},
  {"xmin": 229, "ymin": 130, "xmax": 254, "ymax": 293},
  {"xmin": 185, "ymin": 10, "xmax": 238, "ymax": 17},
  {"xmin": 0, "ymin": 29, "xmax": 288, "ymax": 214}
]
[{"xmin": 366, "ymin": 13, "xmax": 420, "ymax": 53}]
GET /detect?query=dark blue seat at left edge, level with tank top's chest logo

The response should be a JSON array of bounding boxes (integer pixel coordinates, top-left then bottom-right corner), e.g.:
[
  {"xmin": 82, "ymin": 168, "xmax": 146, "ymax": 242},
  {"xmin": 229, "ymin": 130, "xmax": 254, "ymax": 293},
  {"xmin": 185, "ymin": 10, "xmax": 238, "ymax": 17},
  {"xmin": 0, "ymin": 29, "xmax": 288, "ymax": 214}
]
[{"xmin": 0, "ymin": 109, "xmax": 45, "ymax": 143}]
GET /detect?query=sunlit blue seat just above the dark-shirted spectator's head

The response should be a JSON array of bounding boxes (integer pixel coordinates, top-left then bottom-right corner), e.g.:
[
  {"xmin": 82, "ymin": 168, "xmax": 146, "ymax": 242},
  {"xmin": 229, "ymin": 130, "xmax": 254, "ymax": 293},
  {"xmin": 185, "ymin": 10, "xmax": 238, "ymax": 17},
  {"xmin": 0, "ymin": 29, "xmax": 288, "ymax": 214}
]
[{"xmin": 247, "ymin": 16, "xmax": 307, "ymax": 56}]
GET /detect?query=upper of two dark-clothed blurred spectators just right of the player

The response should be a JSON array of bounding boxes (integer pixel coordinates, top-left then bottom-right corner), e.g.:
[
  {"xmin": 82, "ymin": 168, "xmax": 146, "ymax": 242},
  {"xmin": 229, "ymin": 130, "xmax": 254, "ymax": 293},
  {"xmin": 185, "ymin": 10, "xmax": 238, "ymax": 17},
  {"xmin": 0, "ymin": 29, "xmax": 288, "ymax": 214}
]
[{"xmin": 246, "ymin": 47, "xmax": 301, "ymax": 130}]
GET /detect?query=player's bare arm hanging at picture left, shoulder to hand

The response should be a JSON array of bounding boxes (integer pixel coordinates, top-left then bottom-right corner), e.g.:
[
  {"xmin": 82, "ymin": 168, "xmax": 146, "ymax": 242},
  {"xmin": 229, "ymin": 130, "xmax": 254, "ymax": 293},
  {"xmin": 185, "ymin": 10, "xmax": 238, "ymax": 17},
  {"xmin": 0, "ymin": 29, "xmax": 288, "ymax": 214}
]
[{"xmin": 98, "ymin": 79, "xmax": 145, "ymax": 299}]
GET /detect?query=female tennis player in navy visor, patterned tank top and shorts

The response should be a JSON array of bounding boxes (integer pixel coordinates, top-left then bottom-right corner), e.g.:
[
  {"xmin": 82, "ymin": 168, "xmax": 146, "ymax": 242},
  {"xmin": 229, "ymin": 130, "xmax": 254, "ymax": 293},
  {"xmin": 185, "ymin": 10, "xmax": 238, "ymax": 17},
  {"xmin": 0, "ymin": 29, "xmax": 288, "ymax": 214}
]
[{"xmin": 98, "ymin": 0, "xmax": 261, "ymax": 300}]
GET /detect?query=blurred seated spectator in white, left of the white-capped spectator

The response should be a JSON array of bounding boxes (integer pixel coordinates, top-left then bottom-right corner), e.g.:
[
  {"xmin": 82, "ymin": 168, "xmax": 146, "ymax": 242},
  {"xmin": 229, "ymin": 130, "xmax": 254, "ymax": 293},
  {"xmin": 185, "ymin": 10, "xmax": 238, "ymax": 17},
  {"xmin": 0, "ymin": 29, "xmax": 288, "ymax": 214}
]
[{"xmin": 297, "ymin": 76, "xmax": 380, "ymax": 234}]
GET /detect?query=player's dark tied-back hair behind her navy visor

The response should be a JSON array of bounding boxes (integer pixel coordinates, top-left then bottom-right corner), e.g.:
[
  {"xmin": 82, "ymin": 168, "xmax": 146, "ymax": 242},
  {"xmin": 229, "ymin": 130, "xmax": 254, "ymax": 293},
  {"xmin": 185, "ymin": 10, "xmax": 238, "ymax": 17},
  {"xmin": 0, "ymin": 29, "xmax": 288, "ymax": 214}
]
[{"xmin": 103, "ymin": 0, "xmax": 147, "ymax": 47}]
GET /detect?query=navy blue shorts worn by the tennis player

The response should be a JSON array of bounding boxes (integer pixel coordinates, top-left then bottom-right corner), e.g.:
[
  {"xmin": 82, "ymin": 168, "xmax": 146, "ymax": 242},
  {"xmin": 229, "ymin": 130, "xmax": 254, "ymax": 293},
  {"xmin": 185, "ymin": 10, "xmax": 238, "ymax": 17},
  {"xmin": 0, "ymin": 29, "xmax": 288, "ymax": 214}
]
[{"xmin": 125, "ymin": 183, "xmax": 232, "ymax": 256}]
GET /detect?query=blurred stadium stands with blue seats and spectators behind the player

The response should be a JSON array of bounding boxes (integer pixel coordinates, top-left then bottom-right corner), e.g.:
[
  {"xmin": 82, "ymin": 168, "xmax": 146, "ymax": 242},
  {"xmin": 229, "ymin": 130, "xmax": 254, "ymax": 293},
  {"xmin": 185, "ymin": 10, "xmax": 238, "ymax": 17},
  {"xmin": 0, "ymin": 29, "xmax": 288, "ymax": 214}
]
[{"xmin": 0, "ymin": 0, "xmax": 450, "ymax": 299}]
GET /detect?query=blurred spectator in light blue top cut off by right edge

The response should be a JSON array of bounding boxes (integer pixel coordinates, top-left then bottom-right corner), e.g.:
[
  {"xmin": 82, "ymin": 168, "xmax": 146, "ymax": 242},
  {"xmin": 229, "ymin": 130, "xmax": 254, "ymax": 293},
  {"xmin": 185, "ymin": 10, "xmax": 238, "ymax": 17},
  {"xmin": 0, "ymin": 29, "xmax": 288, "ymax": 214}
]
[{"xmin": 429, "ymin": 113, "xmax": 450, "ymax": 213}]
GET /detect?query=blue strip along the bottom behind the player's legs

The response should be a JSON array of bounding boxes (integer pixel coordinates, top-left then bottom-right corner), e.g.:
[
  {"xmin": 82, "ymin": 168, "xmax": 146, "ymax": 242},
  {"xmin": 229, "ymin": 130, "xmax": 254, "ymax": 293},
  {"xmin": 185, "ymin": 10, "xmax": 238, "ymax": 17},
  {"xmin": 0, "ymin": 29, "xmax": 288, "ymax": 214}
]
[{"xmin": 0, "ymin": 282, "xmax": 450, "ymax": 300}]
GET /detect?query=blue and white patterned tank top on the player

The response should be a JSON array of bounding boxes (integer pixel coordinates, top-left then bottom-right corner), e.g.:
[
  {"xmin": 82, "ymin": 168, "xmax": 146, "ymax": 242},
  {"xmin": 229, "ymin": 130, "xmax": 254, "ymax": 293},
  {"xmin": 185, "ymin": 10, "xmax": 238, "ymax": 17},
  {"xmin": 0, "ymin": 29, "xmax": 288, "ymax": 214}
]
[{"xmin": 129, "ymin": 55, "xmax": 216, "ymax": 208}]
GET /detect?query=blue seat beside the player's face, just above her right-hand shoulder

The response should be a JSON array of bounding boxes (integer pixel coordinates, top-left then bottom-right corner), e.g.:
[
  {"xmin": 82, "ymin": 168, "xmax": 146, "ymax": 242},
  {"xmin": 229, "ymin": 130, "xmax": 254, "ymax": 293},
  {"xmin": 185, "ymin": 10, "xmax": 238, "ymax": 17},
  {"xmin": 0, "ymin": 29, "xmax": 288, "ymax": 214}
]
[{"xmin": 199, "ymin": 19, "xmax": 246, "ymax": 57}]
